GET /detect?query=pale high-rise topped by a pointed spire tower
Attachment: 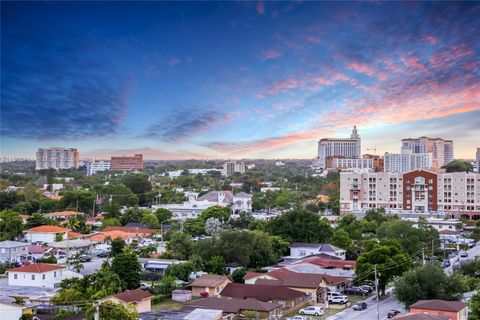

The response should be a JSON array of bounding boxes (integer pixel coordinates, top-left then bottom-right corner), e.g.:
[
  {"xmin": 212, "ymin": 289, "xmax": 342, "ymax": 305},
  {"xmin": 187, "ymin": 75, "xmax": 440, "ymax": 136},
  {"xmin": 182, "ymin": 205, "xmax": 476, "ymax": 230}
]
[{"xmin": 316, "ymin": 126, "xmax": 361, "ymax": 169}]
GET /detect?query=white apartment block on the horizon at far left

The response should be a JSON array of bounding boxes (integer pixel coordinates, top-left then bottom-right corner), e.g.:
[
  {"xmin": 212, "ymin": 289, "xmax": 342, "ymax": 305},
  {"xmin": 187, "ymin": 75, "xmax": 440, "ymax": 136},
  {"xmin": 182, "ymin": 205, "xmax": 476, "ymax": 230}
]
[{"xmin": 35, "ymin": 148, "xmax": 80, "ymax": 170}]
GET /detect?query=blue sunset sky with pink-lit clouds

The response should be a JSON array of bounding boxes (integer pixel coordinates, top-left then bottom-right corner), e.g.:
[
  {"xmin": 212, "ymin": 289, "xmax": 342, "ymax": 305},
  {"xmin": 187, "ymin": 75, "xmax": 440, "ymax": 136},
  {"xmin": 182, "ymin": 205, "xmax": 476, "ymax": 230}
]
[{"xmin": 0, "ymin": 1, "xmax": 480, "ymax": 159}]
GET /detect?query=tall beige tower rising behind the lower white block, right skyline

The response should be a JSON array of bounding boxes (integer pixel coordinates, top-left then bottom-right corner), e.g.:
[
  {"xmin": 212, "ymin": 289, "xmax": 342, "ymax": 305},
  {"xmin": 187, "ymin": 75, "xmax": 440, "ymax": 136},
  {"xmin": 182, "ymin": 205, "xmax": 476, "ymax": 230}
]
[{"xmin": 402, "ymin": 137, "xmax": 453, "ymax": 168}]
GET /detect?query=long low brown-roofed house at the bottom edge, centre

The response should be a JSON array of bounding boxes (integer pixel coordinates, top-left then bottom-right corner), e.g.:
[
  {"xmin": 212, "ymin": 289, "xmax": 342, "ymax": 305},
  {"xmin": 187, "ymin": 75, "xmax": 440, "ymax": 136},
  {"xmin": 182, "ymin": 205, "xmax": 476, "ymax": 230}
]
[{"xmin": 181, "ymin": 297, "xmax": 282, "ymax": 319}]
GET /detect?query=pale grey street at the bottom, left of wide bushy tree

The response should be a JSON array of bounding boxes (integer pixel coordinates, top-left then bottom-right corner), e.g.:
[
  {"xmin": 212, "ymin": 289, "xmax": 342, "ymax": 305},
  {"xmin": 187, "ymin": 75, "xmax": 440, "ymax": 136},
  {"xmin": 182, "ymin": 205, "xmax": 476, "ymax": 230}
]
[{"xmin": 328, "ymin": 289, "xmax": 405, "ymax": 320}]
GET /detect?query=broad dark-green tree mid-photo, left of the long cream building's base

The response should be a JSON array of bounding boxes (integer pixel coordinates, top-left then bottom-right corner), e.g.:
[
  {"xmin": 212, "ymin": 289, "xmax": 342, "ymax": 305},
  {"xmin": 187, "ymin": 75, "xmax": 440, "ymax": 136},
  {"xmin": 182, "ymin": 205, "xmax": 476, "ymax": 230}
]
[{"xmin": 266, "ymin": 209, "xmax": 332, "ymax": 242}]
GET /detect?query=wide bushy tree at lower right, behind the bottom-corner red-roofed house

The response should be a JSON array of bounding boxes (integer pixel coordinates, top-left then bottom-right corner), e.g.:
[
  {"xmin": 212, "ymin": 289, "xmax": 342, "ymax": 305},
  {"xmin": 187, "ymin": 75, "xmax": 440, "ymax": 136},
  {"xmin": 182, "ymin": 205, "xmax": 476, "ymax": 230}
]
[{"xmin": 395, "ymin": 263, "xmax": 468, "ymax": 307}]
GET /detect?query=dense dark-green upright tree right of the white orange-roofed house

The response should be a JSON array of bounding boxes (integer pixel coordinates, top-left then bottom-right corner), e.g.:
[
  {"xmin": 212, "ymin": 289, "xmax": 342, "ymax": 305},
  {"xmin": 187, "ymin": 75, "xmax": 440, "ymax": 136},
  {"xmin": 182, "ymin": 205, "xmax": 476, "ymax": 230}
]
[{"xmin": 112, "ymin": 251, "xmax": 142, "ymax": 290}]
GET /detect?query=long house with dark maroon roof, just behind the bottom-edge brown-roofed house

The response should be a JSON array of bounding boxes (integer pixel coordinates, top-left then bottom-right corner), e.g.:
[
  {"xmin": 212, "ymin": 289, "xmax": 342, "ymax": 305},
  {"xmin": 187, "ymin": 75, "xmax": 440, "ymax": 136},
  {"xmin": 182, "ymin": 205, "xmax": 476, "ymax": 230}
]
[{"xmin": 220, "ymin": 283, "xmax": 307, "ymax": 308}]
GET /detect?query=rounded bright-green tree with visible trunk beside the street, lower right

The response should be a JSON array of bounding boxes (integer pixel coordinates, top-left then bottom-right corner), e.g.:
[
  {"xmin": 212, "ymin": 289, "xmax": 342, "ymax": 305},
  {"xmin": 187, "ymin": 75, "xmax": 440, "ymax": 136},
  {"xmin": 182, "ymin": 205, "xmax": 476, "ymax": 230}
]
[{"xmin": 355, "ymin": 243, "xmax": 412, "ymax": 293}]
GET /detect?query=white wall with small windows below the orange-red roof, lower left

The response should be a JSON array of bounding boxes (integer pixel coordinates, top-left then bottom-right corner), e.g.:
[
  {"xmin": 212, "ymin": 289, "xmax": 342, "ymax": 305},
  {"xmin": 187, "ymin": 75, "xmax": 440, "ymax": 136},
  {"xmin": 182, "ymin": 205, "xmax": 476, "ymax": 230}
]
[{"xmin": 8, "ymin": 269, "xmax": 65, "ymax": 288}]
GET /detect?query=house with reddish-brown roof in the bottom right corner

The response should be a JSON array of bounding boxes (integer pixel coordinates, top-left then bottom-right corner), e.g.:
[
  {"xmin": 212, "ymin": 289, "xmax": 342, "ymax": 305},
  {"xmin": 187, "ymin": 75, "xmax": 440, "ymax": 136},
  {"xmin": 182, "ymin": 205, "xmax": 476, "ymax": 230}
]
[{"xmin": 410, "ymin": 300, "xmax": 468, "ymax": 320}]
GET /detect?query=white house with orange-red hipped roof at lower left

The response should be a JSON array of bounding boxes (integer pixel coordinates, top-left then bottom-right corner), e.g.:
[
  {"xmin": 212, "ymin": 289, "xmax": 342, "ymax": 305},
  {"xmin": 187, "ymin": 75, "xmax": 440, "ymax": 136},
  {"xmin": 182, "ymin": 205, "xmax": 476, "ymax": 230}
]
[{"xmin": 7, "ymin": 263, "xmax": 66, "ymax": 288}]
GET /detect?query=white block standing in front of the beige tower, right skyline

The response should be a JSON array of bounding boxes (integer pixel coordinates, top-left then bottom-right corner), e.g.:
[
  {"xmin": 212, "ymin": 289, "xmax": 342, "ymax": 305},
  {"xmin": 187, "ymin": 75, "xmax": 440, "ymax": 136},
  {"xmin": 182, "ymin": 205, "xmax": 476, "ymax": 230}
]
[{"xmin": 384, "ymin": 150, "xmax": 432, "ymax": 172}]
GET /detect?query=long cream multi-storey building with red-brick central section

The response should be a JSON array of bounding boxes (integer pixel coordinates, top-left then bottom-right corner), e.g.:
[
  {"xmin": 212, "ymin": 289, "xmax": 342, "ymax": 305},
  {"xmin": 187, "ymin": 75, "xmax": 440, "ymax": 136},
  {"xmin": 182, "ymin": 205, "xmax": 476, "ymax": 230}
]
[{"xmin": 340, "ymin": 170, "xmax": 480, "ymax": 220}]
